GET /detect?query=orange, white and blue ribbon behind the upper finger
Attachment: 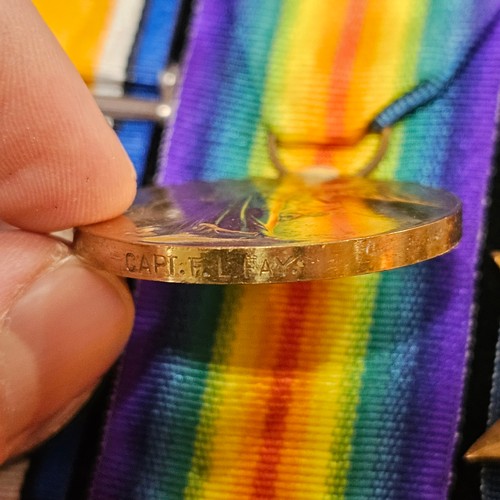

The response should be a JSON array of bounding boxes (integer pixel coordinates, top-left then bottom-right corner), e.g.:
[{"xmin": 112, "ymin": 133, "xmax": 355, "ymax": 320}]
[{"xmin": 34, "ymin": 0, "xmax": 180, "ymax": 183}]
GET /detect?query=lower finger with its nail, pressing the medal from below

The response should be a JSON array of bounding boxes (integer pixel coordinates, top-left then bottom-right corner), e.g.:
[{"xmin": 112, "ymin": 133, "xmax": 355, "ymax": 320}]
[{"xmin": 0, "ymin": 229, "xmax": 133, "ymax": 463}]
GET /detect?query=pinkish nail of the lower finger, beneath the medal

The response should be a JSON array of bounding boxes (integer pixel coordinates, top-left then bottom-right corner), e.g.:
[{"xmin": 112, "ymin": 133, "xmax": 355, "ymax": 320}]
[{"xmin": 0, "ymin": 257, "xmax": 133, "ymax": 450}]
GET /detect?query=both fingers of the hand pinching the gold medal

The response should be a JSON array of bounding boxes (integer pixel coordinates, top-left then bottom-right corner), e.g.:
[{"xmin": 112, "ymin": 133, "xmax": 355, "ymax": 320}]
[{"xmin": 0, "ymin": 0, "xmax": 136, "ymax": 463}]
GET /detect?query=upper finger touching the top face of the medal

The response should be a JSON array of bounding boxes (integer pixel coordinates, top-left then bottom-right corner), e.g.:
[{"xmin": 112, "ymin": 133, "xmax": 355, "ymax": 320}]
[{"xmin": 0, "ymin": 0, "xmax": 136, "ymax": 232}]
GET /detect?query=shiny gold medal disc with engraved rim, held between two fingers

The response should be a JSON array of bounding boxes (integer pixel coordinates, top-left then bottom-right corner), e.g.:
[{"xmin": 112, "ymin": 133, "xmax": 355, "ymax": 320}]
[{"xmin": 74, "ymin": 175, "xmax": 461, "ymax": 284}]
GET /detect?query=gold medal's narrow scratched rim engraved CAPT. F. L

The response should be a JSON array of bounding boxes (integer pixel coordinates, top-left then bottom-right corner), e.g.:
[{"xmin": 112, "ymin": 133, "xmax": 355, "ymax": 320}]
[{"xmin": 73, "ymin": 205, "xmax": 462, "ymax": 285}]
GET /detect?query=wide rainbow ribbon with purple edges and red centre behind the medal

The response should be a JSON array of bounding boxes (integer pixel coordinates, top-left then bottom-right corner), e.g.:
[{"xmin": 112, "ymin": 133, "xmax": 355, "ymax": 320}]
[{"xmin": 92, "ymin": 0, "xmax": 500, "ymax": 500}]
